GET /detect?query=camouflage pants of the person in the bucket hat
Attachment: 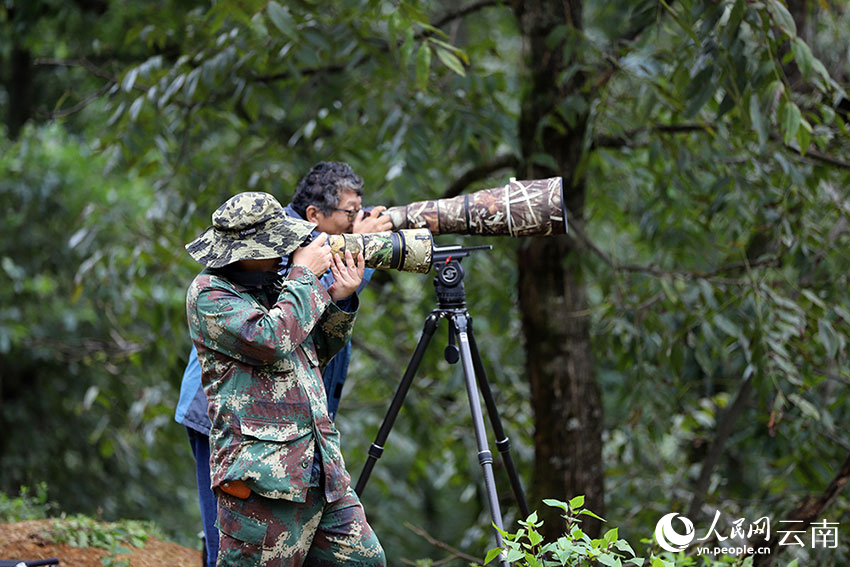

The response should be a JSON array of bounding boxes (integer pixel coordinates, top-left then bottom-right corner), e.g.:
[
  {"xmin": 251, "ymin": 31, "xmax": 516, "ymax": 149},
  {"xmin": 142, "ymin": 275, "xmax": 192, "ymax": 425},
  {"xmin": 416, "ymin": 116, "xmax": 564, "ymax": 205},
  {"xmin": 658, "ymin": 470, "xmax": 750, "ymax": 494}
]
[{"xmin": 218, "ymin": 487, "xmax": 387, "ymax": 567}]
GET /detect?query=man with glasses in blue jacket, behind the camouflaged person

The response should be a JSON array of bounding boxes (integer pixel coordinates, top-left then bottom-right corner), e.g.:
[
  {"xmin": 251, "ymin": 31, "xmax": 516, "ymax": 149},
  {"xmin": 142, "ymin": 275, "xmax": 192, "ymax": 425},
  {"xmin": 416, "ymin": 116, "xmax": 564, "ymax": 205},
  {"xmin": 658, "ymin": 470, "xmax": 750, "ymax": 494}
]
[{"xmin": 174, "ymin": 162, "xmax": 392, "ymax": 567}]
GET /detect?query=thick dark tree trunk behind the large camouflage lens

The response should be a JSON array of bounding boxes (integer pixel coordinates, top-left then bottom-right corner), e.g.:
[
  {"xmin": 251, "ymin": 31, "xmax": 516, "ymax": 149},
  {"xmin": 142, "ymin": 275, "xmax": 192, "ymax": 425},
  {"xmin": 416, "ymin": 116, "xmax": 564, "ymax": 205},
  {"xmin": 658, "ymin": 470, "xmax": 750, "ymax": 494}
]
[{"xmin": 514, "ymin": 0, "xmax": 604, "ymax": 541}]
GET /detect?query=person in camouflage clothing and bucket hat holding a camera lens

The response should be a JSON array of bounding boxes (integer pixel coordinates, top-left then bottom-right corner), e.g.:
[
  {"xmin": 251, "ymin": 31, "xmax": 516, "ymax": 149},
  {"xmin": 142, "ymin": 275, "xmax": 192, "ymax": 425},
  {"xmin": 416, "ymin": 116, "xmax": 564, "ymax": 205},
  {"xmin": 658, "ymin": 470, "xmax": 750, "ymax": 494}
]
[{"xmin": 186, "ymin": 193, "xmax": 386, "ymax": 567}]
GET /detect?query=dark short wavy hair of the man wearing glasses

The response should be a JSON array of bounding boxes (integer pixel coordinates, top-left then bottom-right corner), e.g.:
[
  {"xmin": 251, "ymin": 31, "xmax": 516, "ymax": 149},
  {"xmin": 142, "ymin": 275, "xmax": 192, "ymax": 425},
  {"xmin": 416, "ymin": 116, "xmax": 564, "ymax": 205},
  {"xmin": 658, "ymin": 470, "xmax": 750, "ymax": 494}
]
[{"xmin": 292, "ymin": 161, "xmax": 363, "ymax": 218}]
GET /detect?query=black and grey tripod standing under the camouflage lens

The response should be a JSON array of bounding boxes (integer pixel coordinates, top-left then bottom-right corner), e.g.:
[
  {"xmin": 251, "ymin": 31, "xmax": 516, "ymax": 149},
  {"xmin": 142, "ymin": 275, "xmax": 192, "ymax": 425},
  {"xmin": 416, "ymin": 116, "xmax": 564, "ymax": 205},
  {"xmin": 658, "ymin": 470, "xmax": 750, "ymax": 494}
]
[{"xmin": 354, "ymin": 246, "xmax": 530, "ymax": 566}]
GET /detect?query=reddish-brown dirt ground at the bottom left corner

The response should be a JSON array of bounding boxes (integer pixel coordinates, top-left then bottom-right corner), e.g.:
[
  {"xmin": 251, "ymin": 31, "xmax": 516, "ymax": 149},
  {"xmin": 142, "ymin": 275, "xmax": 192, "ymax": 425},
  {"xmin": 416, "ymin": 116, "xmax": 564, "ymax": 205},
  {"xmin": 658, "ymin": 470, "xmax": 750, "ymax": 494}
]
[{"xmin": 0, "ymin": 520, "xmax": 201, "ymax": 567}]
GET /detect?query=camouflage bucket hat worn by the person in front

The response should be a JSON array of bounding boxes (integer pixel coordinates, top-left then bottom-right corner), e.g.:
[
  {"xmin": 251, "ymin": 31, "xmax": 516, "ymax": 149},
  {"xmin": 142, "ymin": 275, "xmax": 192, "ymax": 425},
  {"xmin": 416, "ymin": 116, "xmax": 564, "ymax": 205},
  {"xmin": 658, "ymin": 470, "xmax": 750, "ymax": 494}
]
[{"xmin": 186, "ymin": 192, "xmax": 316, "ymax": 268}]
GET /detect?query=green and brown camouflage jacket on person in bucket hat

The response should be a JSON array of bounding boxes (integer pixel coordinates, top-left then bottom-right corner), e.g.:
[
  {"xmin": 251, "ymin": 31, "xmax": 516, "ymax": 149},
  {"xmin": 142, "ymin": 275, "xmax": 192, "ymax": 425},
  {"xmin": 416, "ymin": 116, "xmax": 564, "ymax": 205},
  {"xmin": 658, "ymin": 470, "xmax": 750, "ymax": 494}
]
[{"xmin": 186, "ymin": 266, "xmax": 357, "ymax": 502}]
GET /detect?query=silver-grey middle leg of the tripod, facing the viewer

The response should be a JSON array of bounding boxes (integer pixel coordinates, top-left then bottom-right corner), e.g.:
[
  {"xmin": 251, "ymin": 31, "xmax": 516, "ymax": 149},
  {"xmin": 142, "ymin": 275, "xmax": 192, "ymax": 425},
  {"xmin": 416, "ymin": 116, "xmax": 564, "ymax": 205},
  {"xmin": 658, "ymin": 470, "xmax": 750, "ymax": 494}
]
[{"xmin": 451, "ymin": 313, "xmax": 507, "ymax": 567}]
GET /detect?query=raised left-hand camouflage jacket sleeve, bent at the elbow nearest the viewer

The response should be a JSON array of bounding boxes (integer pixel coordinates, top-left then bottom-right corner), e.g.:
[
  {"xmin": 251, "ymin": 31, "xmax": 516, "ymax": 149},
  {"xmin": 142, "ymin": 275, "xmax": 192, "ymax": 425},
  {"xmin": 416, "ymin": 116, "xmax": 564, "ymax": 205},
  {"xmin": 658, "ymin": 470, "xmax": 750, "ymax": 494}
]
[{"xmin": 187, "ymin": 266, "xmax": 332, "ymax": 365}]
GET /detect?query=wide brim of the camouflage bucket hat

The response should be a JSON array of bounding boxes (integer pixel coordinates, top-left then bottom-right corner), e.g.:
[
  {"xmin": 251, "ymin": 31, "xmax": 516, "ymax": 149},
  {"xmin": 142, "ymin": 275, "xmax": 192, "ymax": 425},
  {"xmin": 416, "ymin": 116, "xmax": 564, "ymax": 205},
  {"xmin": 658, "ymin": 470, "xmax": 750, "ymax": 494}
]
[{"xmin": 186, "ymin": 216, "xmax": 316, "ymax": 268}]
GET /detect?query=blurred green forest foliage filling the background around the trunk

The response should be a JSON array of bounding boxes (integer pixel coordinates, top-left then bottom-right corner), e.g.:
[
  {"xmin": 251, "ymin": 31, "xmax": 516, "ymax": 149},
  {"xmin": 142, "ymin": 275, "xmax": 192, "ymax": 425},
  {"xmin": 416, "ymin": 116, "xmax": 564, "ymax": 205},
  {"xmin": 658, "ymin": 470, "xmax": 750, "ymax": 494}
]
[{"xmin": 0, "ymin": 0, "xmax": 850, "ymax": 565}]
